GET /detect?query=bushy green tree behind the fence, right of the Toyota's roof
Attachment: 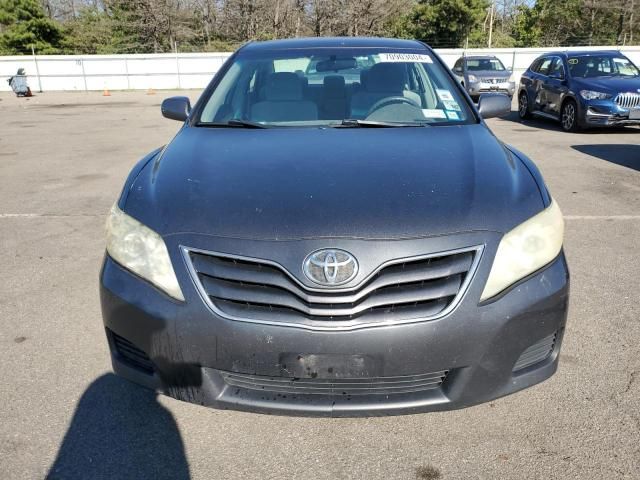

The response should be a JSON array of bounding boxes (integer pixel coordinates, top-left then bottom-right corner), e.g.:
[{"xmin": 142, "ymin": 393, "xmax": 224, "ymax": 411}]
[{"xmin": 405, "ymin": 0, "xmax": 489, "ymax": 47}]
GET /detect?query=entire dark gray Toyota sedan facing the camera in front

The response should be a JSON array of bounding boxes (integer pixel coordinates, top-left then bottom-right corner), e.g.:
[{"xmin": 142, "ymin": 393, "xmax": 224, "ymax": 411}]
[{"xmin": 100, "ymin": 38, "xmax": 569, "ymax": 416}]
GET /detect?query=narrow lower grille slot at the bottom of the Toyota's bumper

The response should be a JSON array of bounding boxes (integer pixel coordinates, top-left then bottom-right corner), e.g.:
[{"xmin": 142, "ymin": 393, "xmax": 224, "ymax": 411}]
[{"xmin": 220, "ymin": 370, "xmax": 449, "ymax": 396}]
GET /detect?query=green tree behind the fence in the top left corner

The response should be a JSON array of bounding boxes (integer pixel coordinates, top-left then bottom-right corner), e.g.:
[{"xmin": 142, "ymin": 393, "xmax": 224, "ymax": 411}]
[{"xmin": 0, "ymin": 0, "xmax": 62, "ymax": 55}]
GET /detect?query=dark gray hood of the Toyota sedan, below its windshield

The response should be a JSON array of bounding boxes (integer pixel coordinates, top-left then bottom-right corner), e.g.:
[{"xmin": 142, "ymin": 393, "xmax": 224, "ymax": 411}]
[{"xmin": 121, "ymin": 124, "xmax": 543, "ymax": 240}]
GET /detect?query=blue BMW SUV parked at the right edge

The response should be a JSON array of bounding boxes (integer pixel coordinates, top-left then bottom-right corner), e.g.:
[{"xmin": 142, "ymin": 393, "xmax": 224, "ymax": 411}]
[{"xmin": 518, "ymin": 51, "xmax": 640, "ymax": 132}]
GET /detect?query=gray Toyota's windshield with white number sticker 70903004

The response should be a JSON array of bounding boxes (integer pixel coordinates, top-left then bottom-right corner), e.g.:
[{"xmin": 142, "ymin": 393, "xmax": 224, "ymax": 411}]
[{"xmin": 196, "ymin": 48, "xmax": 477, "ymax": 128}]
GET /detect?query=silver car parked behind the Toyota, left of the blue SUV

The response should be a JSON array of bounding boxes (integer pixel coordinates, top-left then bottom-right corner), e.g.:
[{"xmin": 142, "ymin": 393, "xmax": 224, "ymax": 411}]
[{"xmin": 453, "ymin": 55, "xmax": 516, "ymax": 102}]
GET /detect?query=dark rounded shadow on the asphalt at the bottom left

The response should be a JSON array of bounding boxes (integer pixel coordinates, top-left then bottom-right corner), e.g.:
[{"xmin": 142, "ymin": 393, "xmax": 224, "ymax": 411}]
[{"xmin": 46, "ymin": 374, "xmax": 190, "ymax": 480}]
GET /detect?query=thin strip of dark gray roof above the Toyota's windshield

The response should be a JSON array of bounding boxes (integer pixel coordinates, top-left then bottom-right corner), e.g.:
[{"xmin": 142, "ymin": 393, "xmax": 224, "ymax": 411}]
[{"xmin": 242, "ymin": 37, "xmax": 428, "ymax": 51}]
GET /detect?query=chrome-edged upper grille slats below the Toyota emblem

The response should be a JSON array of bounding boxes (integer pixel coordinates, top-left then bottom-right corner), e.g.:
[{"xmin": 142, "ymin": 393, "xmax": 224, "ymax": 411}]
[{"xmin": 184, "ymin": 249, "xmax": 476, "ymax": 323}]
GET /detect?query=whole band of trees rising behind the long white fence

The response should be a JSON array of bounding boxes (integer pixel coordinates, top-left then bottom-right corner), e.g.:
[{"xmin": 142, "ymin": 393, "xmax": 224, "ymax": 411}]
[{"xmin": 0, "ymin": 0, "xmax": 640, "ymax": 54}]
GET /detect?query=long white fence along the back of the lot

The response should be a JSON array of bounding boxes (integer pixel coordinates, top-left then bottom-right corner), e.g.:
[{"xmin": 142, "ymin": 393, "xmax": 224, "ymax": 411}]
[{"xmin": 0, "ymin": 46, "xmax": 640, "ymax": 91}]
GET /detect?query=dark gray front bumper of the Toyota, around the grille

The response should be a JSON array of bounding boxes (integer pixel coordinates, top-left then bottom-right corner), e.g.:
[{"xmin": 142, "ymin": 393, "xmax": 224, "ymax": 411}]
[{"xmin": 100, "ymin": 234, "xmax": 569, "ymax": 416}]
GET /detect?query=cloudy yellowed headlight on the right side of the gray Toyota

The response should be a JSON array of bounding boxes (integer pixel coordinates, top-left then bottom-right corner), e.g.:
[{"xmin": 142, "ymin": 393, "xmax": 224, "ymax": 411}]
[{"xmin": 480, "ymin": 200, "xmax": 564, "ymax": 301}]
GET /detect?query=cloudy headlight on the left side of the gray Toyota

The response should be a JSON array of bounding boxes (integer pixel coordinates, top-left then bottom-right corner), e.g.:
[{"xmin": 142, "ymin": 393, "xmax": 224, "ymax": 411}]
[{"xmin": 107, "ymin": 204, "xmax": 184, "ymax": 301}]
